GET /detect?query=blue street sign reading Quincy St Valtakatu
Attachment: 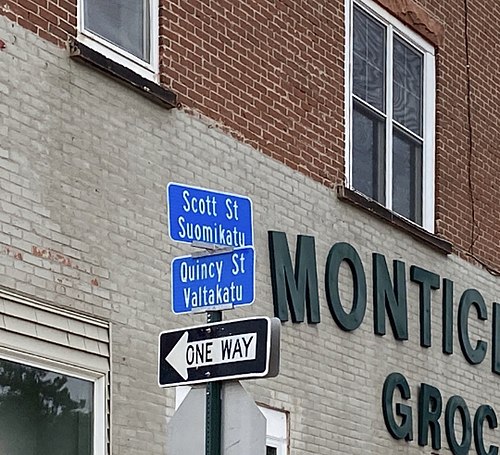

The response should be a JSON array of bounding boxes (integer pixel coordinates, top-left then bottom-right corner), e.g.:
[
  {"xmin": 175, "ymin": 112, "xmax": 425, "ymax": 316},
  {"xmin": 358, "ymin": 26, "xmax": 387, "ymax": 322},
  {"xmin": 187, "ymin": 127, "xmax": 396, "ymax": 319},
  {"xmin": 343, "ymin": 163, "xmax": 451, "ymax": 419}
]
[{"xmin": 171, "ymin": 247, "xmax": 255, "ymax": 314}]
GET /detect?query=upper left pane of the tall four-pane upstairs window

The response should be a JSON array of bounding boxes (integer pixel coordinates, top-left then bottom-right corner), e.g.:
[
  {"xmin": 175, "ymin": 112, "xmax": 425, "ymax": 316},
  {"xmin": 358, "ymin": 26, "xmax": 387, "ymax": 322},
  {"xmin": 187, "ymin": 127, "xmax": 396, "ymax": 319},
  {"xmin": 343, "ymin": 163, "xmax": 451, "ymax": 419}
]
[{"xmin": 353, "ymin": 7, "xmax": 385, "ymax": 112}]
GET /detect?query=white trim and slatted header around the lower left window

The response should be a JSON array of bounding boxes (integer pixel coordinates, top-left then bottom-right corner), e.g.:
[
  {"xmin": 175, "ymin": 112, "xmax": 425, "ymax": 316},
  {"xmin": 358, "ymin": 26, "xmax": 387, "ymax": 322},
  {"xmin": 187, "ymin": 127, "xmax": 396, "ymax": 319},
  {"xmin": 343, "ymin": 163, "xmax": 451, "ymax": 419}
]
[{"xmin": 0, "ymin": 287, "xmax": 112, "ymax": 455}]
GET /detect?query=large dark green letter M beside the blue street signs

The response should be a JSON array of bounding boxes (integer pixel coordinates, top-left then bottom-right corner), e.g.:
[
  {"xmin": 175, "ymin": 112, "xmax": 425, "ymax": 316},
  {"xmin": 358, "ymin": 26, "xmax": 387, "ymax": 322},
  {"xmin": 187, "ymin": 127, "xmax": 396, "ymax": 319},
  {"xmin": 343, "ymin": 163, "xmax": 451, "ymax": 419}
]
[{"xmin": 268, "ymin": 231, "xmax": 320, "ymax": 324}]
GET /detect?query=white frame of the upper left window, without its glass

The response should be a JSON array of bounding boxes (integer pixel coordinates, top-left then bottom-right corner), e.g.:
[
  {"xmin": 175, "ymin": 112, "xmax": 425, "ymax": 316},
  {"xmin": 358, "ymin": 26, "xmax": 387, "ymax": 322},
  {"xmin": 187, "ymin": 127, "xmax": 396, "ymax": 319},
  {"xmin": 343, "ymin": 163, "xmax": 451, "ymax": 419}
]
[{"xmin": 77, "ymin": 0, "xmax": 159, "ymax": 82}]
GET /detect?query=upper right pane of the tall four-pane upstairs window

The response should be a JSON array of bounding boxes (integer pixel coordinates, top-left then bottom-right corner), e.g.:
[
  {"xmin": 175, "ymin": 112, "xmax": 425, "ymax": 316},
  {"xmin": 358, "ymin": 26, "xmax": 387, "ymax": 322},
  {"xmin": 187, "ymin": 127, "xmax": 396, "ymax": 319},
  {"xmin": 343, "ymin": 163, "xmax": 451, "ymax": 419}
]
[{"xmin": 393, "ymin": 36, "xmax": 423, "ymax": 136}]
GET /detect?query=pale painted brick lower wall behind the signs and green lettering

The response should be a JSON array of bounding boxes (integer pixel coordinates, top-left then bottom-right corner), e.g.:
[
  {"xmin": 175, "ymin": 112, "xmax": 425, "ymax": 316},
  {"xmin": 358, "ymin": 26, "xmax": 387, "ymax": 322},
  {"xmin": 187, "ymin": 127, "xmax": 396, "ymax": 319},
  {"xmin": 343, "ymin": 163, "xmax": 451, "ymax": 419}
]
[{"xmin": 0, "ymin": 17, "xmax": 500, "ymax": 455}]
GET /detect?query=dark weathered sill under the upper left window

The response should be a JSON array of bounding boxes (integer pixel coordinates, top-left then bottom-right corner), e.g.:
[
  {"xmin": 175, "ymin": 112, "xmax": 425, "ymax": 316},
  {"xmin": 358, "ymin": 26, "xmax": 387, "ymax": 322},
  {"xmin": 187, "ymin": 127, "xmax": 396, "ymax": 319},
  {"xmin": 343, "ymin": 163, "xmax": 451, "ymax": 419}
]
[{"xmin": 70, "ymin": 41, "xmax": 177, "ymax": 109}]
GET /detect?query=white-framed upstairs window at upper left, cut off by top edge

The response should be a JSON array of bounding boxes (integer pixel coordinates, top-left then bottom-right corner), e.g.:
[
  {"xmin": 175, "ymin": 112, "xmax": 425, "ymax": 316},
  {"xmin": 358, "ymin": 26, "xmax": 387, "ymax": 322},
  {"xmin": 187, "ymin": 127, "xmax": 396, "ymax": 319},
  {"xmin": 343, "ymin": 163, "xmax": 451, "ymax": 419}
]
[{"xmin": 78, "ymin": 0, "xmax": 158, "ymax": 80}]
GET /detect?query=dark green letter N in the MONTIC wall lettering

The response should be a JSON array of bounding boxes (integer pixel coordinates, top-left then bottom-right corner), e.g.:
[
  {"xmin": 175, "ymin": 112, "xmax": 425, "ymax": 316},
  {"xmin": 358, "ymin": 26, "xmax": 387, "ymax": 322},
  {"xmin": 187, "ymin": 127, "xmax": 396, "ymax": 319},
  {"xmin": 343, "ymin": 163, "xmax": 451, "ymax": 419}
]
[{"xmin": 373, "ymin": 253, "xmax": 408, "ymax": 340}]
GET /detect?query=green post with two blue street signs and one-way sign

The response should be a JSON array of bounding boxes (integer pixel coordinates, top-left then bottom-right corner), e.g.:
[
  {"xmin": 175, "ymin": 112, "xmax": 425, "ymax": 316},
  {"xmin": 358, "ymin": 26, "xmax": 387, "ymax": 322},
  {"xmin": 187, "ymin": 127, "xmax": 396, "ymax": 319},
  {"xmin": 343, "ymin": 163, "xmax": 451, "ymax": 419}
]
[{"xmin": 165, "ymin": 183, "xmax": 280, "ymax": 455}]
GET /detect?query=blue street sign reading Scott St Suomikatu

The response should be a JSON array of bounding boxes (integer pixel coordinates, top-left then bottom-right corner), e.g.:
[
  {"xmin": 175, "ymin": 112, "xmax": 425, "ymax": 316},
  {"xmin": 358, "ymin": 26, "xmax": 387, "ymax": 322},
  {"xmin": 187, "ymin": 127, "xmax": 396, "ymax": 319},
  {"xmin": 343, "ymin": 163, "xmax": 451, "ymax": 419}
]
[{"xmin": 167, "ymin": 183, "xmax": 253, "ymax": 248}]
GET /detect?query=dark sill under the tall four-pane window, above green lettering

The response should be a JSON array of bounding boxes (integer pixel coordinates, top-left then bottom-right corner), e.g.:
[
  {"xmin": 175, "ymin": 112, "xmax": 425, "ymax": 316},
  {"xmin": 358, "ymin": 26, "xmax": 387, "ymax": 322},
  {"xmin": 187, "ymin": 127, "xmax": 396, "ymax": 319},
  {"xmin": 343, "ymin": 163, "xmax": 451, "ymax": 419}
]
[{"xmin": 337, "ymin": 185, "xmax": 452, "ymax": 254}]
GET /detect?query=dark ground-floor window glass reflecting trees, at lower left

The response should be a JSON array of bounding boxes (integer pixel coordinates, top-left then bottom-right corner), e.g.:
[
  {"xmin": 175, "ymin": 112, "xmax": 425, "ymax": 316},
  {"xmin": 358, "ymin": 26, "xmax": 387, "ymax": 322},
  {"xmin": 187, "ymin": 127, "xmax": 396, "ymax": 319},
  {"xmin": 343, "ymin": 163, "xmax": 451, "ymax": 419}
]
[{"xmin": 0, "ymin": 359, "xmax": 93, "ymax": 455}]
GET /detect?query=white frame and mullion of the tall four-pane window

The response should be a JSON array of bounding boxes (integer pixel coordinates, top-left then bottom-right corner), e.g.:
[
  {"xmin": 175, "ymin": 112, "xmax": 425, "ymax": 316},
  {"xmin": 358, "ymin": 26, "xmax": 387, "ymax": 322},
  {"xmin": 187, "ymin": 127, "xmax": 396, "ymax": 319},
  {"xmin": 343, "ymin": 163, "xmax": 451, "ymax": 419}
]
[{"xmin": 345, "ymin": 0, "xmax": 436, "ymax": 233}]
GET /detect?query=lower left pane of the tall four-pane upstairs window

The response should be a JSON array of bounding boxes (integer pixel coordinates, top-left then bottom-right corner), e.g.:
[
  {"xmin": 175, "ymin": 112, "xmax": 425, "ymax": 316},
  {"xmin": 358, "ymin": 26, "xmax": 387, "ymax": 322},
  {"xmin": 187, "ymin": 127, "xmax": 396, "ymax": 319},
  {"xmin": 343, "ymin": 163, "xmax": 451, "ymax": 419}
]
[{"xmin": 352, "ymin": 103, "xmax": 385, "ymax": 203}]
